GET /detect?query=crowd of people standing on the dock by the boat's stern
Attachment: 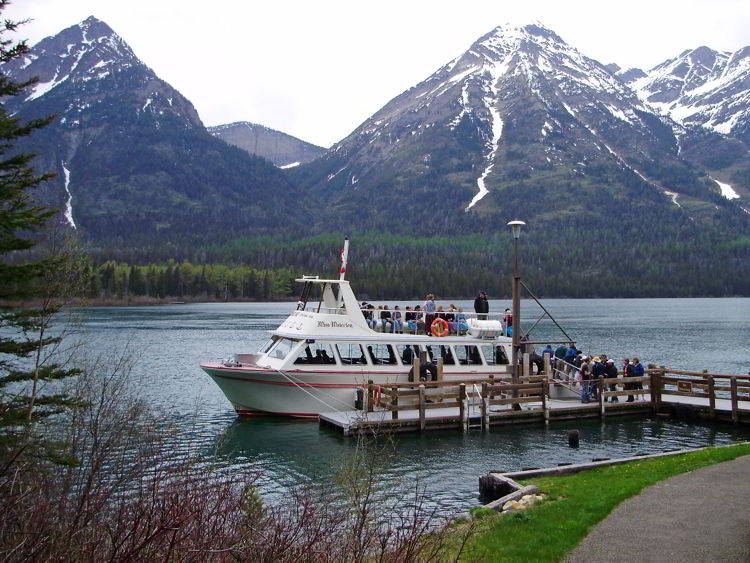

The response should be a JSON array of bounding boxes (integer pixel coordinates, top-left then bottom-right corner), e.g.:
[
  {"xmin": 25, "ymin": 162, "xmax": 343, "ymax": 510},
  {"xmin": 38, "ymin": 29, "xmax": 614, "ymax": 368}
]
[{"xmin": 542, "ymin": 344, "xmax": 645, "ymax": 403}]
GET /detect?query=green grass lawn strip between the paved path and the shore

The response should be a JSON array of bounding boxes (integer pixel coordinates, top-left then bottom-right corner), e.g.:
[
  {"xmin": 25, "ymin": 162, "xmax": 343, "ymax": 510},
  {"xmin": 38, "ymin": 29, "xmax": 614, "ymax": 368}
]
[{"xmin": 450, "ymin": 443, "xmax": 750, "ymax": 562}]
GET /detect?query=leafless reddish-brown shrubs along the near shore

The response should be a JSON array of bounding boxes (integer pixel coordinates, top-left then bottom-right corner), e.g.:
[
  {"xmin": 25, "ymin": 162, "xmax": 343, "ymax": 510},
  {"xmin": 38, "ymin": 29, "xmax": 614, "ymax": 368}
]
[{"xmin": 0, "ymin": 359, "xmax": 471, "ymax": 563}]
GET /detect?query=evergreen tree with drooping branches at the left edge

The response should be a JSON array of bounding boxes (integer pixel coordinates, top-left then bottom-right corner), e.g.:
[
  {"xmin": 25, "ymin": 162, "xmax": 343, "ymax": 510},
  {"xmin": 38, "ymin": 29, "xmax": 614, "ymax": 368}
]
[{"xmin": 0, "ymin": 4, "xmax": 78, "ymax": 462}]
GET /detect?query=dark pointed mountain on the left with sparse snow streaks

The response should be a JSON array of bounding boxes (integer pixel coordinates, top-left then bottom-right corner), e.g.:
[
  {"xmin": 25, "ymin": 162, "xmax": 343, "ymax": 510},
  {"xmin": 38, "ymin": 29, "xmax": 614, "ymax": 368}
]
[{"xmin": 0, "ymin": 17, "xmax": 304, "ymax": 246}]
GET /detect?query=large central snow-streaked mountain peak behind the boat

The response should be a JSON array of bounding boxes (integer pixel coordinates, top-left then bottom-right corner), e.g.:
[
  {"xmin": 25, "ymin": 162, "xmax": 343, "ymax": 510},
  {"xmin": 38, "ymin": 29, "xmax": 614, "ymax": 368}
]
[{"xmin": 300, "ymin": 24, "xmax": 748, "ymax": 229}]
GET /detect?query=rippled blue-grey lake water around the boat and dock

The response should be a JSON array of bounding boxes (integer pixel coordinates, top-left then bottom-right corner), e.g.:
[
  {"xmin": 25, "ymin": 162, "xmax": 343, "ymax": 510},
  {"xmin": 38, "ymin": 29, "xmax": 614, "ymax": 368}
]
[{"xmin": 78, "ymin": 298, "xmax": 750, "ymax": 513}]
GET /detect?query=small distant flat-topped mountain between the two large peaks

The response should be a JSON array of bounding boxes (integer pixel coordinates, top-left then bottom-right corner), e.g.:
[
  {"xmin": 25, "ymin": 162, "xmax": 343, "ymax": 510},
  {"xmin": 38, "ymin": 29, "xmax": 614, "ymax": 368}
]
[{"xmin": 208, "ymin": 121, "xmax": 326, "ymax": 168}]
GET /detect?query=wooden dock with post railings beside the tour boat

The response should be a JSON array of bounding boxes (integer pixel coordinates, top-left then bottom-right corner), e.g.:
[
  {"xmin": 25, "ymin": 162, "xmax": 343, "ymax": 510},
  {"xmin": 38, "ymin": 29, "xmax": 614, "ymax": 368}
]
[{"xmin": 320, "ymin": 367, "xmax": 750, "ymax": 436}]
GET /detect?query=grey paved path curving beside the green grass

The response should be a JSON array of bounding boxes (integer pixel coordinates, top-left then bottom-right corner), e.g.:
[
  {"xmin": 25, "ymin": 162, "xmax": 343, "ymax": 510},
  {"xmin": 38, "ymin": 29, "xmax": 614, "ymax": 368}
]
[{"xmin": 565, "ymin": 456, "xmax": 750, "ymax": 563}]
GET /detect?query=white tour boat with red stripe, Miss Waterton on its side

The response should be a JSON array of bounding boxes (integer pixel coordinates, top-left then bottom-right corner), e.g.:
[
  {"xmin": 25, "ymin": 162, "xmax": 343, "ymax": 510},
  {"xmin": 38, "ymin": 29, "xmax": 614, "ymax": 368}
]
[{"xmin": 201, "ymin": 274, "xmax": 524, "ymax": 417}]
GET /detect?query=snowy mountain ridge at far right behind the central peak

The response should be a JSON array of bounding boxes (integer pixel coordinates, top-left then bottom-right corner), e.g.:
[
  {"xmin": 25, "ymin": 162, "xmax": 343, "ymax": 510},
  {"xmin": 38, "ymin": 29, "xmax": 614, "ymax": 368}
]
[{"xmin": 625, "ymin": 46, "xmax": 750, "ymax": 146}]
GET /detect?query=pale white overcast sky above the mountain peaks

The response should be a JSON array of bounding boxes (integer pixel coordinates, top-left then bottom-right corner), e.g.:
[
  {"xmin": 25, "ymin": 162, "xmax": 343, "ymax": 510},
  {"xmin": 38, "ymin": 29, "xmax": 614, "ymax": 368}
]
[{"xmin": 2, "ymin": 0, "xmax": 750, "ymax": 147}]
